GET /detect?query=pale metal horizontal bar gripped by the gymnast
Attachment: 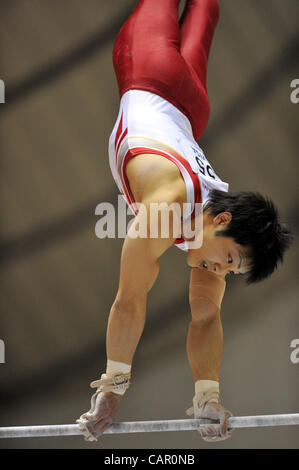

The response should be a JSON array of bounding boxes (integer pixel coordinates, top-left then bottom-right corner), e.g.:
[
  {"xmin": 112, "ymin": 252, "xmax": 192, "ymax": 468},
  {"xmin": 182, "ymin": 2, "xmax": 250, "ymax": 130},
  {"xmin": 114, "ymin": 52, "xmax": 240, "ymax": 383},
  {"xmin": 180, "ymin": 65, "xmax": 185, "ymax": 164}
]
[{"xmin": 0, "ymin": 413, "xmax": 299, "ymax": 438}]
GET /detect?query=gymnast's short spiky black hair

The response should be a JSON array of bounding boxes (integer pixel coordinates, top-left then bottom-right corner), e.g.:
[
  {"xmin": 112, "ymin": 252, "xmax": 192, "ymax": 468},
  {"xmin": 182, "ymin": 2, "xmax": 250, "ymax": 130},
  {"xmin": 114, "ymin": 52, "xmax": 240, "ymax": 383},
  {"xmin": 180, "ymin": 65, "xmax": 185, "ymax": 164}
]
[{"xmin": 205, "ymin": 190, "xmax": 293, "ymax": 284}]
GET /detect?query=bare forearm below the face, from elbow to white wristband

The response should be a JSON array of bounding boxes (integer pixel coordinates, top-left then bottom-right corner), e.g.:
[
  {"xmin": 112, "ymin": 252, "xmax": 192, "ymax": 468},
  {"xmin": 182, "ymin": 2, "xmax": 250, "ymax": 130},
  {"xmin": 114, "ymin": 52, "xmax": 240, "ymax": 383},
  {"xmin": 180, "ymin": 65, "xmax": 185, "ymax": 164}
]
[{"xmin": 187, "ymin": 308, "xmax": 223, "ymax": 382}]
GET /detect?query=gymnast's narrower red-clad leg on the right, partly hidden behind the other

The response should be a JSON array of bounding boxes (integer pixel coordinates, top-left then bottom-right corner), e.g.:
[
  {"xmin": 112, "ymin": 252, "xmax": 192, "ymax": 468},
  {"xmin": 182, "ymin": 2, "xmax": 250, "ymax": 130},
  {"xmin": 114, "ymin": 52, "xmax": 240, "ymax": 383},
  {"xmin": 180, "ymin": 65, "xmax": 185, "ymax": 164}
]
[{"xmin": 180, "ymin": 0, "xmax": 219, "ymax": 89}]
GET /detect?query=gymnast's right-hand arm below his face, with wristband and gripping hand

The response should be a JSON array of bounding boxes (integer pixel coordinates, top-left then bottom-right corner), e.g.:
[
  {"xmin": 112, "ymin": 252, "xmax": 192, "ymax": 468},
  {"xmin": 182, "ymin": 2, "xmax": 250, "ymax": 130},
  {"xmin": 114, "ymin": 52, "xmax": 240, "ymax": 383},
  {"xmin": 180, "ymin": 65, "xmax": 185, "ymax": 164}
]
[{"xmin": 187, "ymin": 268, "xmax": 232, "ymax": 441}]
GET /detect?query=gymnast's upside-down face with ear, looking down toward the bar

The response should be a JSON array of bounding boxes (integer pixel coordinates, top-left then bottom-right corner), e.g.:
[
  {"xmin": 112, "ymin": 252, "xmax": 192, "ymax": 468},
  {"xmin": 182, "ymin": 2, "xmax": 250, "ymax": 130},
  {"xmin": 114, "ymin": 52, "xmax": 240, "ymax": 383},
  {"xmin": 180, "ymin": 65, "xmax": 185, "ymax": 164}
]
[{"xmin": 187, "ymin": 212, "xmax": 251, "ymax": 276}]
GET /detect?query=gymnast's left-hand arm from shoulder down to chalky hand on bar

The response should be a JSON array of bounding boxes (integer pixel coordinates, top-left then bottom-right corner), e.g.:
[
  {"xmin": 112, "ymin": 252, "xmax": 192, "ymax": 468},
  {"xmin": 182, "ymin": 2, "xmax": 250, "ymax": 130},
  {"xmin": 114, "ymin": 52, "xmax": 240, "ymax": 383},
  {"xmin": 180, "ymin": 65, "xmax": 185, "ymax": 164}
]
[{"xmin": 77, "ymin": 188, "xmax": 180, "ymax": 440}]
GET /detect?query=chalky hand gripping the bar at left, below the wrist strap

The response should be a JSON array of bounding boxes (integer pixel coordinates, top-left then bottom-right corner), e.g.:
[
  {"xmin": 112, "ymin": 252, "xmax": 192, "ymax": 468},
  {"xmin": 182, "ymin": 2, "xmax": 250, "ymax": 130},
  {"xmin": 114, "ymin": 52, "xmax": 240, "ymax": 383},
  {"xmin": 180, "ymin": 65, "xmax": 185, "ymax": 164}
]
[{"xmin": 76, "ymin": 392, "xmax": 122, "ymax": 441}]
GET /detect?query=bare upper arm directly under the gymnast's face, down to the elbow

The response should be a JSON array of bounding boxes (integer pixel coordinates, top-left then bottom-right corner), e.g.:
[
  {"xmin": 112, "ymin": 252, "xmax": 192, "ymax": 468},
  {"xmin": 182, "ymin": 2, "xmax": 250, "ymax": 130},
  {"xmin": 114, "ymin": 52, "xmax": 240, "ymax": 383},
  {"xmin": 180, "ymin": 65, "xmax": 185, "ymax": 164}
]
[{"xmin": 189, "ymin": 268, "xmax": 226, "ymax": 311}]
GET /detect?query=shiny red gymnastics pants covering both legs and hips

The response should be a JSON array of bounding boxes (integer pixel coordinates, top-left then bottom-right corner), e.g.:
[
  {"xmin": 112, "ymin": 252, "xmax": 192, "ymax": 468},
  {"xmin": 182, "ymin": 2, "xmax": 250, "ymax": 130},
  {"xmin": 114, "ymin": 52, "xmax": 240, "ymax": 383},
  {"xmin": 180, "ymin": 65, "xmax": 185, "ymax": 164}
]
[{"xmin": 113, "ymin": 0, "xmax": 219, "ymax": 140}]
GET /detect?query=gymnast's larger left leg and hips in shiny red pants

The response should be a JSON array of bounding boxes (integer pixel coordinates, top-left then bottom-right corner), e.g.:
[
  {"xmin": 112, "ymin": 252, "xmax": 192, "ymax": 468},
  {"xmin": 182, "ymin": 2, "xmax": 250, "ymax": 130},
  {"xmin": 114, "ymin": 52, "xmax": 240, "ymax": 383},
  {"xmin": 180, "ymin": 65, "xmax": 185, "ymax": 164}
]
[{"xmin": 113, "ymin": 0, "xmax": 213, "ymax": 140}]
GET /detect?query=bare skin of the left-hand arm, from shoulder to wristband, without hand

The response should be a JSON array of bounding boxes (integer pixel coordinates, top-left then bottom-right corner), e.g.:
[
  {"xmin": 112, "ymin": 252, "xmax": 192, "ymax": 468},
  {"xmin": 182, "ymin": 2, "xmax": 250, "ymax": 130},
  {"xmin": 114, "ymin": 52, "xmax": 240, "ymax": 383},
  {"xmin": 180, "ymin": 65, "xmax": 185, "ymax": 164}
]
[{"xmin": 107, "ymin": 207, "xmax": 173, "ymax": 364}]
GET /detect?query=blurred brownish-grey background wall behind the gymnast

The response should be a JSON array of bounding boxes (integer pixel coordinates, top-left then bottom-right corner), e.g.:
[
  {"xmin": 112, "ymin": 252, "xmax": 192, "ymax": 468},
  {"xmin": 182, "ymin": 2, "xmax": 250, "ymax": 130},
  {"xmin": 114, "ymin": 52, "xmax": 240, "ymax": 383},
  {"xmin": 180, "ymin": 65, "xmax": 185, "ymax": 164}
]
[{"xmin": 0, "ymin": 0, "xmax": 299, "ymax": 449}]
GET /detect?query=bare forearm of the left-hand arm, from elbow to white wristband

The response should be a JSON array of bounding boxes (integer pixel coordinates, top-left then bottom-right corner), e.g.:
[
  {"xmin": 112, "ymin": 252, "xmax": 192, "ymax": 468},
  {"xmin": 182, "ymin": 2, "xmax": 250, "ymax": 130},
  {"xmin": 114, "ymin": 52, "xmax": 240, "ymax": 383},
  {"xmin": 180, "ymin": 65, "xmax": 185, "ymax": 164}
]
[{"xmin": 106, "ymin": 298, "xmax": 146, "ymax": 364}]
